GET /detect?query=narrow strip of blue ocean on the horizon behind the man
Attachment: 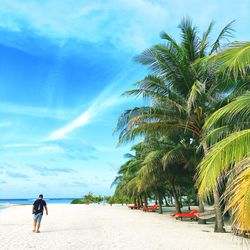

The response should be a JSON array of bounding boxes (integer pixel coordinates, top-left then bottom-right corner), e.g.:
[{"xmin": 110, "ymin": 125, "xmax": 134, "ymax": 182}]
[{"xmin": 0, "ymin": 198, "xmax": 78, "ymax": 209}]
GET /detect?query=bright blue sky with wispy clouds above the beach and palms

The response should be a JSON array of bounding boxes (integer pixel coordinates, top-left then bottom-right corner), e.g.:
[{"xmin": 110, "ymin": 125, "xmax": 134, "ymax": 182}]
[{"xmin": 0, "ymin": 0, "xmax": 250, "ymax": 198}]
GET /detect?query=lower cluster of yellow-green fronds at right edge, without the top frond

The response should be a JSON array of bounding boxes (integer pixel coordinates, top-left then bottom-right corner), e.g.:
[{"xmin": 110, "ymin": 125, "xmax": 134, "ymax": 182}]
[{"xmin": 197, "ymin": 92, "xmax": 250, "ymax": 234}]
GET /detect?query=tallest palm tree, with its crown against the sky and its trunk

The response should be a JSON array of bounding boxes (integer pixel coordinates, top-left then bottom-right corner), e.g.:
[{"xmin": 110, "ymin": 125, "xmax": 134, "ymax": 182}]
[{"xmin": 117, "ymin": 19, "xmax": 235, "ymax": 232}]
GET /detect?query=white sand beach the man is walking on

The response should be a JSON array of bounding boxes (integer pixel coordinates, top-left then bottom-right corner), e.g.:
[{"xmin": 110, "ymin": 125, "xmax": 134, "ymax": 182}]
[{"xmin": 0, "ymin": 204, "xmax": 250, "ymax": 250}]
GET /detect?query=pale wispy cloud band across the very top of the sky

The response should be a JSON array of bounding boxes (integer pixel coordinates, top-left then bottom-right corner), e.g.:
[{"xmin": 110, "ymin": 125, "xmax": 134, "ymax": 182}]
[{"xmin": 0, "ymin": 0, "xmax": 249, "ymax": 52}]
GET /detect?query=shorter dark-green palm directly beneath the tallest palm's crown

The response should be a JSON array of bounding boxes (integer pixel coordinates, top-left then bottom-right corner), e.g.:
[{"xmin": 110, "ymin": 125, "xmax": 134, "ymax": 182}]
[{"xmin": 139, "ymin": 136, "xmax": 193, "ymax": 213}]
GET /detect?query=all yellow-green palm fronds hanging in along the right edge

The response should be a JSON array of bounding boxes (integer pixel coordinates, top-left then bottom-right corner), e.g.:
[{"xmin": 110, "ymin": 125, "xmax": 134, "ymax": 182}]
[{"xmin": 197, "ymin": 42, "xmax": 250, "ymax": 232}]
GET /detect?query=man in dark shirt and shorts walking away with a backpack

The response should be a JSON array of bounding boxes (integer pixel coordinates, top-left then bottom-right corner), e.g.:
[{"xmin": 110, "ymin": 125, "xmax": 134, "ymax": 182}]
[{"xmin": 32, "ymin": 194, "xmax": 48, "ymax": 233}]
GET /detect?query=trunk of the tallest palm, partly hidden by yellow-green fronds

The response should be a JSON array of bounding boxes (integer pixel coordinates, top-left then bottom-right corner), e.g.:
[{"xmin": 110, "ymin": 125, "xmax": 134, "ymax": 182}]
[{"xmin": 202, "ymin": 142, "xmax": 225, "ymax": 233}]
